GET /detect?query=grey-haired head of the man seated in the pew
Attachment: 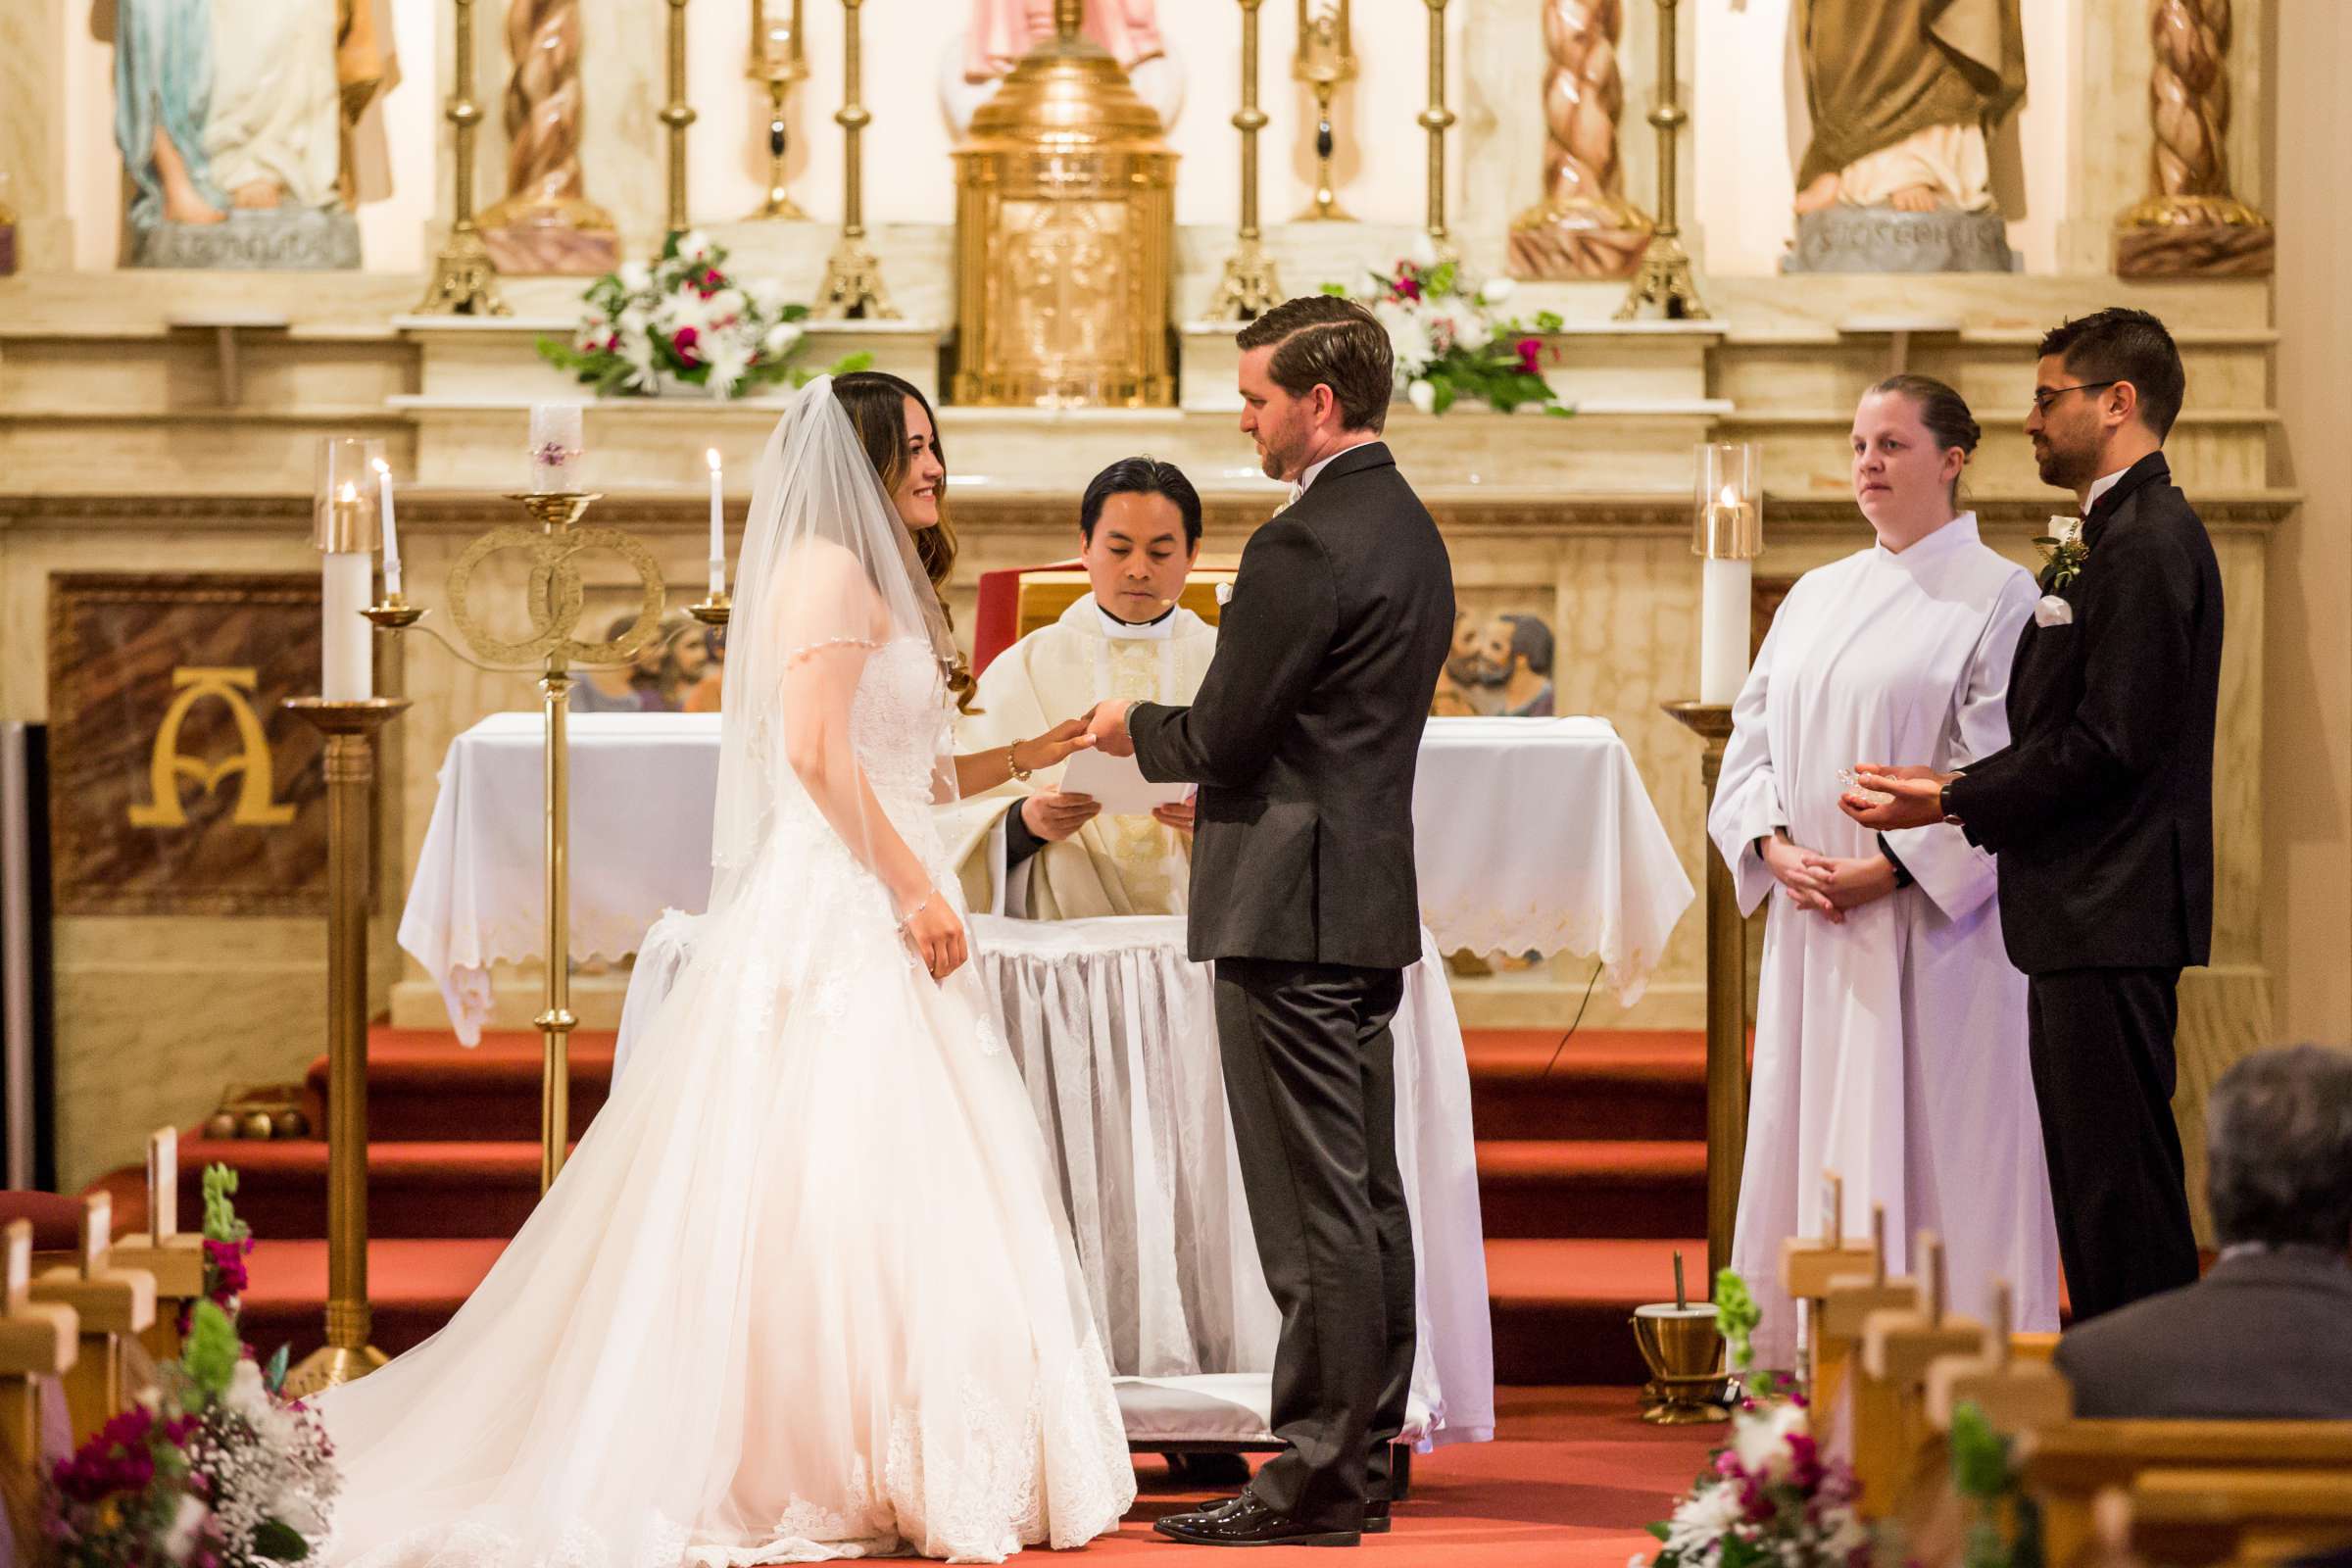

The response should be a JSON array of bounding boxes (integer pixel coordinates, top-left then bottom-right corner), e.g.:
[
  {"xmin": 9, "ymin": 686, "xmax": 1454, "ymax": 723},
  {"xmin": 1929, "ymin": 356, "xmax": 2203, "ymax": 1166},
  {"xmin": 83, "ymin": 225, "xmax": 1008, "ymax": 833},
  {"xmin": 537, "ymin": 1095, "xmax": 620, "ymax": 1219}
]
[{"xmin": 2206, "ymin": 1046, "xmax": 2352, "ymax": 1253}]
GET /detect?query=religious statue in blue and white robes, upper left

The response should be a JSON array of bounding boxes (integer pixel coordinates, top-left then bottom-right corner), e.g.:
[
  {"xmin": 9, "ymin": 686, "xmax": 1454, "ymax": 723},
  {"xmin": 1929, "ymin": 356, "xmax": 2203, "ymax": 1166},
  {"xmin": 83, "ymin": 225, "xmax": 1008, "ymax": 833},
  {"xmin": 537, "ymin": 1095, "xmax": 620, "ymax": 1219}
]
[{"xmin": 116, "ymin": 0, "xmax": 388, "ymax": 268}]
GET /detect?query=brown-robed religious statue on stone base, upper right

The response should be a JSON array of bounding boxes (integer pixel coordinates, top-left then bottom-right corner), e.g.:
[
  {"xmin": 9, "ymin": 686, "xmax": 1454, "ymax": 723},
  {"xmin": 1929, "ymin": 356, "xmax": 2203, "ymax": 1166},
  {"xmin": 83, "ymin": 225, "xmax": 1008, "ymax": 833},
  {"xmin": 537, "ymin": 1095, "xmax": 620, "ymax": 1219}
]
[{"xmin": 1789, "ymin": 0, "xmax": 2025, "ymax": 270}]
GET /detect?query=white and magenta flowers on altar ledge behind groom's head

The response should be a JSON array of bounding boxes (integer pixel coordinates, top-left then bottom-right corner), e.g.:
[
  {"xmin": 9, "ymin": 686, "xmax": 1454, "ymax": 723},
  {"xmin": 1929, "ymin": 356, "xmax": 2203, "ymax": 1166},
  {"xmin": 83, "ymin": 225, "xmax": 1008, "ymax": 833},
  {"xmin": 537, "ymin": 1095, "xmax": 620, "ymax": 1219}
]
[{"xmin": 1324, "ymin": 240, "xmax": 1574, "ymax": 416}]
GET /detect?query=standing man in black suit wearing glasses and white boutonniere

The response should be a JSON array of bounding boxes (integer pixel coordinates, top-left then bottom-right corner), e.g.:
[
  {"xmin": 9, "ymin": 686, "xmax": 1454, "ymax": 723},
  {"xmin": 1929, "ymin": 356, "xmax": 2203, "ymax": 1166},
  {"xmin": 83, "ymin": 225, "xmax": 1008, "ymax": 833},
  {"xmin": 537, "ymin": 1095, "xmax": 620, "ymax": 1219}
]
[{"xmin": 1844, "ymin": 311, "xmax": 2223, "ymax": 1321}]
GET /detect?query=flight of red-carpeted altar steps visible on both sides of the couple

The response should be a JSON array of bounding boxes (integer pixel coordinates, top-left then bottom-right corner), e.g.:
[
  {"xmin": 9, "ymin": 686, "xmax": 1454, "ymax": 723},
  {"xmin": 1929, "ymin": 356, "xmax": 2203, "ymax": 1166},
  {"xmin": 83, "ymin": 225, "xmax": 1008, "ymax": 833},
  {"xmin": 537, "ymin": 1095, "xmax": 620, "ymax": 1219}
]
[{"xmin": 101, "ymin": 1027, "xmax": 1705, "ymax": 1385}]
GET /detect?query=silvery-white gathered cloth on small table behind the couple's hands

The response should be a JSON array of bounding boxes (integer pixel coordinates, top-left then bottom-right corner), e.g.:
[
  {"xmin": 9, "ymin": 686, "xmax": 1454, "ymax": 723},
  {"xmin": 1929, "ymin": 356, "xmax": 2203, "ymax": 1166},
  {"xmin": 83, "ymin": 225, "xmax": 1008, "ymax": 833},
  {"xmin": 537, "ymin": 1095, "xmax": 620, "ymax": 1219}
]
[{"xmin": 971, "ymin": 914, "xmax": 1494, "ymax": 1446}]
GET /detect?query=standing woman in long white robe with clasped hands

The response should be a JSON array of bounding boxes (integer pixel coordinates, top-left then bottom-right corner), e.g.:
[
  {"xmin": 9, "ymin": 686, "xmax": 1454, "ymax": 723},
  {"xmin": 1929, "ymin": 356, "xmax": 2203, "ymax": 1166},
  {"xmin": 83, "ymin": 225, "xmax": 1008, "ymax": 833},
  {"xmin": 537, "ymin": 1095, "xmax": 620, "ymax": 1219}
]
[{"xmin": 1707, "ymin": 376, "xmax": 2058, "ymax": 1368}]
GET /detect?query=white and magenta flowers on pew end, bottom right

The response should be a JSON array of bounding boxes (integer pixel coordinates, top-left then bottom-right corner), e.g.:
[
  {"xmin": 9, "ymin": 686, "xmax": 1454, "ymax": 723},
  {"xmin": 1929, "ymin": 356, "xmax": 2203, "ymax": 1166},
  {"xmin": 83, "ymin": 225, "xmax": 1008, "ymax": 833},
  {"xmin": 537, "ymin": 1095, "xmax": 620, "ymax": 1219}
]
[{"xmin": 1628, "ymin": 1269, "xmax": 1870, "ymax": 1568}]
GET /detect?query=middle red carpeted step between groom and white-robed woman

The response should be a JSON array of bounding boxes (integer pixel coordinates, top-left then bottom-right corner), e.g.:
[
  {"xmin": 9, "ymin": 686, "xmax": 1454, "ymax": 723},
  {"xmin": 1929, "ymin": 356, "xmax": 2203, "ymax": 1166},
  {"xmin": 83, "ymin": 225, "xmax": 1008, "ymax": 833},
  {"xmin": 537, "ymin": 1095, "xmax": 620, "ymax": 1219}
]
[{"xmin": 1477, "ymin": 1138, "xmax": 1707, "ymax": 1239}]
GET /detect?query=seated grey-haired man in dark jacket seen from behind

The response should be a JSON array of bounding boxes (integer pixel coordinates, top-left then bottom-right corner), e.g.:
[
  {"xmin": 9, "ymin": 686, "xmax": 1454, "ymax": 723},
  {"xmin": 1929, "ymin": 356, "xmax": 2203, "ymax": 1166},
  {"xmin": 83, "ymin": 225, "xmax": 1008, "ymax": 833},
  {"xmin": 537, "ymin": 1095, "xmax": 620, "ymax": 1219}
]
[{"xmin": 2058, "ymin": 1046, "xmax": 2352, "ymax": 1420}]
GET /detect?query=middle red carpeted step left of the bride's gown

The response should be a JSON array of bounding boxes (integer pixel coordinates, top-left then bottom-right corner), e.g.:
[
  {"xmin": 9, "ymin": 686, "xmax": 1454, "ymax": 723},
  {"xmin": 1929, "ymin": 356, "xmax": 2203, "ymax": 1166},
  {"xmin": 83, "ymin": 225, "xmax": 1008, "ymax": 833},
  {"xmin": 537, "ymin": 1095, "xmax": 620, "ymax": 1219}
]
[{"xmin": 141, "ymin": 1138, "xmax": 539, "ymax": 1242}]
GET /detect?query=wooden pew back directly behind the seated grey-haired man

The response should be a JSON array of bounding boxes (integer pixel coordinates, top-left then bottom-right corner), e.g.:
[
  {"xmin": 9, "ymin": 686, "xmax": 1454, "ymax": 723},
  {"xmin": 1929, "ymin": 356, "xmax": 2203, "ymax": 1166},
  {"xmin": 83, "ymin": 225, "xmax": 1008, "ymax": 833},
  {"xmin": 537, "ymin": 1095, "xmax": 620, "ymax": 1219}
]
[{"xmin": 2021, "ymin": 1420, "xmax": 2352, "ymax": 1568}]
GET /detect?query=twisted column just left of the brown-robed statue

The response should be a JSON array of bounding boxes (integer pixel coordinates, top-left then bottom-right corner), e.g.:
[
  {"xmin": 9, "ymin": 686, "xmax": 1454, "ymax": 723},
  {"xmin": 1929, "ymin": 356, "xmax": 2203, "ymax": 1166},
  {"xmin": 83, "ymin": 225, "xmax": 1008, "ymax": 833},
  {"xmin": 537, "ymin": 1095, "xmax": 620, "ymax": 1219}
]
[{"xmin": 1510, "ymin": 0, "xmax": 1651, "ymax": 277}]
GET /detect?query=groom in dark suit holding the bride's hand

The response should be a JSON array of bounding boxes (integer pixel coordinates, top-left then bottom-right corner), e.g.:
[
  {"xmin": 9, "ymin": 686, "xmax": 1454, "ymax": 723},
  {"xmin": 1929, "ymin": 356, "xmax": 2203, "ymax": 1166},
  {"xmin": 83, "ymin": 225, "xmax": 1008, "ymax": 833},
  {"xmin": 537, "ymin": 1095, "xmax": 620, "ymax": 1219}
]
[{"xmin": 1092, "ymin": 294, "xmax": 1453, "ymax": 1546}]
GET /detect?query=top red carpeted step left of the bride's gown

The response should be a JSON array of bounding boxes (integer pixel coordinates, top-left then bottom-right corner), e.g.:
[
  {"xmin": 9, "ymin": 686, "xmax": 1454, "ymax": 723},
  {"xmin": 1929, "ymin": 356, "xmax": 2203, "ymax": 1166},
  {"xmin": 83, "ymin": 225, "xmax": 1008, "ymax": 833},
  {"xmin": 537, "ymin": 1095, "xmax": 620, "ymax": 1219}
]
[{"xmin": 304, "ymin": 1025, "xmax": 613, "ymax": 1143}]
